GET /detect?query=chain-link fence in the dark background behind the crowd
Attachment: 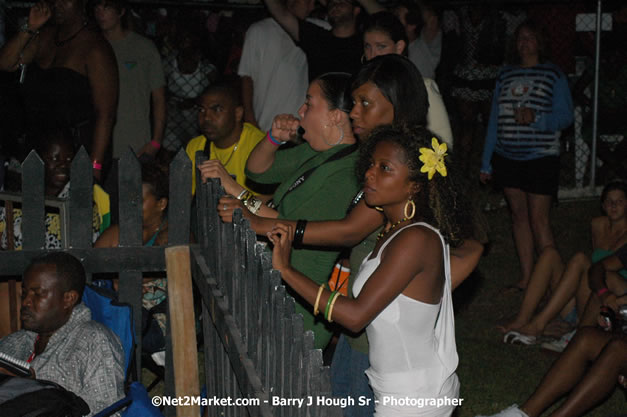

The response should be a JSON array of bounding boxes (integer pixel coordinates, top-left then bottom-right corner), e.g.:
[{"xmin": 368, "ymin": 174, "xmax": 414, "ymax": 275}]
[{"xmin": 0, "ymin": 0, "xmax": 627, "ymax": 198}]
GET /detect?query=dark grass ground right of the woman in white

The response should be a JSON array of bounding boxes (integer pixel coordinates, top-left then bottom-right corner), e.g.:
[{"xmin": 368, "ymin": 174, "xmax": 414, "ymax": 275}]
[{"xmin": 455, "ymin": 190, "xmax": 627, "ymax": 417}]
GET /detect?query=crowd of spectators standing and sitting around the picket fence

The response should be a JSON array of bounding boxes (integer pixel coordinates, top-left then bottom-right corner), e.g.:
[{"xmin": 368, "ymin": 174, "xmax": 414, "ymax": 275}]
[{"xmin": 0, "ymin": 0, "xmax": 627, "ymax": 417}]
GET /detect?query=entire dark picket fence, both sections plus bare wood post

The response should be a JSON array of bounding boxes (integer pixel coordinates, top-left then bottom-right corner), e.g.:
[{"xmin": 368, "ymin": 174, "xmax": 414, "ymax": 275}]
[{"xmin": 0, "ymin": 149, "xmax": 340, "ymax": 417}]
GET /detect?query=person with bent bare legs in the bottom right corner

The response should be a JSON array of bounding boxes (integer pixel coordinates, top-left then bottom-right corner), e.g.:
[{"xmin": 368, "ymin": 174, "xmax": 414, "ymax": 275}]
[{"xmin": 477, "ymin": 327, "xmax": 627, "ymax": 417}]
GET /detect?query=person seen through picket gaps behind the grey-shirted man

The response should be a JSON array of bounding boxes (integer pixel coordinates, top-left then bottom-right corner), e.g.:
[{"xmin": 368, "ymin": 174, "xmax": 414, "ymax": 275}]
[{"xmin": 94, "ymin": 163, "xmax": 169, "ymax": 353}]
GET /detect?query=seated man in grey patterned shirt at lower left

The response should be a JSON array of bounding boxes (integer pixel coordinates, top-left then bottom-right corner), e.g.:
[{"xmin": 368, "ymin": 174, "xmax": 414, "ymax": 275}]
[{"xmin": 0, "ymin": 252, "xmax": 124, "ymax": 416}]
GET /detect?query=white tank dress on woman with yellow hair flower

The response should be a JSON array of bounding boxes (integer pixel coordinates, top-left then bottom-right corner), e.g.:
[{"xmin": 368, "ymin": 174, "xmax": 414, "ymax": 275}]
[{"xmin": 353, "ymin": 223, "xmax": 459, "ymax": 417}]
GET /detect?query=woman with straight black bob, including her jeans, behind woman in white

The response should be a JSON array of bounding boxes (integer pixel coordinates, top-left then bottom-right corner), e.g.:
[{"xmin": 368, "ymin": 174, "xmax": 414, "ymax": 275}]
[{"xmin": 219, "ymin": 54, "xmax": 483, "ymax": 416}]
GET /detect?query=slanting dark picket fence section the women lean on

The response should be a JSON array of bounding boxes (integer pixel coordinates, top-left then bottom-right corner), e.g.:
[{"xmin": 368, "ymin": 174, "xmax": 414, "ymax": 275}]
[{"xmin": 192, "ymin": 164, "xmax": 341, "ymax": 417}]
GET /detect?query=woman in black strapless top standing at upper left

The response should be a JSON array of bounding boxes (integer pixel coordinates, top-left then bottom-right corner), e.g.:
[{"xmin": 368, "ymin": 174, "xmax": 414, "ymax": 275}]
[{"xmin": 0, "ymin": 0, "xmax": 118, "ymax": 180}]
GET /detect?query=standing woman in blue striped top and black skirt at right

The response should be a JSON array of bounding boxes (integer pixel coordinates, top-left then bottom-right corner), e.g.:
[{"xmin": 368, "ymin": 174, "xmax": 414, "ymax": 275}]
[{"xmin": 480, "ymin": 20, "xmax": 573, "ymax": 289}]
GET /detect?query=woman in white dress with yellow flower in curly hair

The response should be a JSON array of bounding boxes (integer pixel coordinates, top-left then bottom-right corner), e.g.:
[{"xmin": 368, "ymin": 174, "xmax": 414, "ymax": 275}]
[{"xmin": 268, "ymin": 126, "xmax": 471, "ymax": 417}]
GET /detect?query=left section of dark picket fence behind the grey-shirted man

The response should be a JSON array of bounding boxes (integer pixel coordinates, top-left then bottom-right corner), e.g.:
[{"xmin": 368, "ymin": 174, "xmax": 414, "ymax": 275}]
[{"xmin": 0, "ymin": 148, "xmax": 192, "ymax": 416}]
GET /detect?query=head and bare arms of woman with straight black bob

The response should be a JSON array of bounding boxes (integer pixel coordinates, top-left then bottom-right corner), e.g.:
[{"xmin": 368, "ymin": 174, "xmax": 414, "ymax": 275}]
[{"xmin": 218, "ymin": 55, "xmax": 483, "ymax": 288}]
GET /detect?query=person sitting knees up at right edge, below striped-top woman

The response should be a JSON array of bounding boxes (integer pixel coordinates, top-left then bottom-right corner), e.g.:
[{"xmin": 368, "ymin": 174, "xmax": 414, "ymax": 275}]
[{"xmin": 501, "ymin": 181, "xmax": 627, "ymax": 344}]
